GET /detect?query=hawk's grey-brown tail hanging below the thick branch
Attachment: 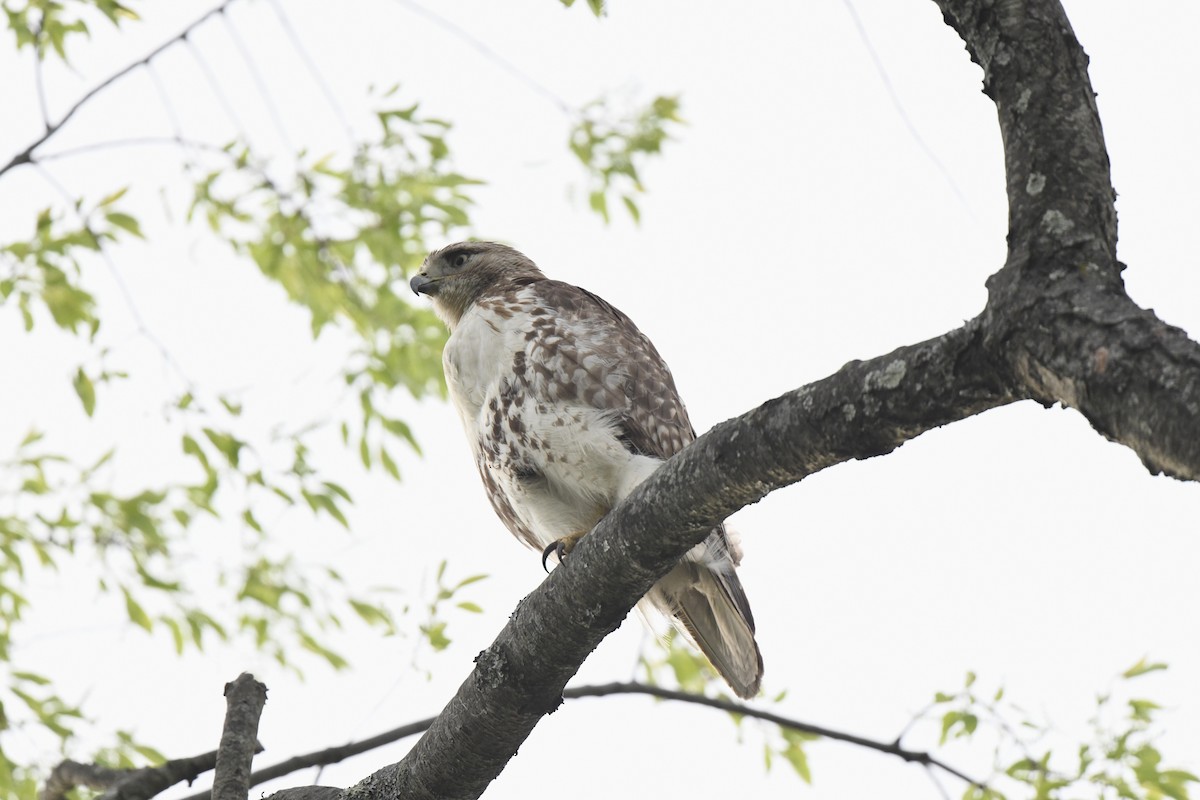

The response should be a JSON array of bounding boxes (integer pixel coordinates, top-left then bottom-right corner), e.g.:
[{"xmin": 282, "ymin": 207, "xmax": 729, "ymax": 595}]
[{"xmin": 647, "ymin": 560, "xmax": 762, "ymax": 699}]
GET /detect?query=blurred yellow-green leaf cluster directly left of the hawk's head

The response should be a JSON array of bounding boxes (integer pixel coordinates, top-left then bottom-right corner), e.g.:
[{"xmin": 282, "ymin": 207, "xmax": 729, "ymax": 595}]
[{"xmin": 192, "ymin": 95, "xmax": 479, "ymax": 470}]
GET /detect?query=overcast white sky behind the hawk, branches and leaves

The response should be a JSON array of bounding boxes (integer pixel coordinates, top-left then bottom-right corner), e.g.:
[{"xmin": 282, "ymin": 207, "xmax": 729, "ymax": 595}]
[{"xmin": 0, "ymin": 0, "xmax": 1200, "ymax": 799}]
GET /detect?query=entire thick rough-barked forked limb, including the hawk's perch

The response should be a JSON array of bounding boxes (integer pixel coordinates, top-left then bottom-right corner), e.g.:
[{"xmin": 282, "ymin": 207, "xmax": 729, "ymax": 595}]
[{"xmin": 267, "ymin": 0, "xmax": 1200, "ymax": 800}]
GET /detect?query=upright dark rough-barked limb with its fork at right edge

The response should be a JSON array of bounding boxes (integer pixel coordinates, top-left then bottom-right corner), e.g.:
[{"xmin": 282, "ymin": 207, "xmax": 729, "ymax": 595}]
[{"xmin": 937, "ymin": 0, "xmax": 1200, "ymax": 480}]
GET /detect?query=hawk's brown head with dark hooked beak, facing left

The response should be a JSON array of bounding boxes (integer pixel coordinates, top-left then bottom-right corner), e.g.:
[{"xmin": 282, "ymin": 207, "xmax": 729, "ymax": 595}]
[{"xmin": 408, "ymin": 241, "xmax": 546, "ymax": 327}]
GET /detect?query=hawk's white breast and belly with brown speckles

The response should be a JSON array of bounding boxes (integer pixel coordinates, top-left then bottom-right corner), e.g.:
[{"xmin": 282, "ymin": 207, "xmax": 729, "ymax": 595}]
[{"xmin": 443, "ymin": 287, "xmax": 658, "ymax": 548}]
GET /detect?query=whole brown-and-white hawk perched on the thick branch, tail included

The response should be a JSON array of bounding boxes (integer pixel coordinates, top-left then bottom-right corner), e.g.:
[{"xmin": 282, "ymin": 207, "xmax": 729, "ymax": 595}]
[{"xmin": 410, "ymin": 242, "xmax": 762, "ymax": 697}]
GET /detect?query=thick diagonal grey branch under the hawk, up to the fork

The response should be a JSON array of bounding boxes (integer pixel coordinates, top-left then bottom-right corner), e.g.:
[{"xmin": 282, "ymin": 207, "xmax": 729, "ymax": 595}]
[{"xmin": 321, "ymin": 323, "xmax": 1014, "ymax": 800}]
